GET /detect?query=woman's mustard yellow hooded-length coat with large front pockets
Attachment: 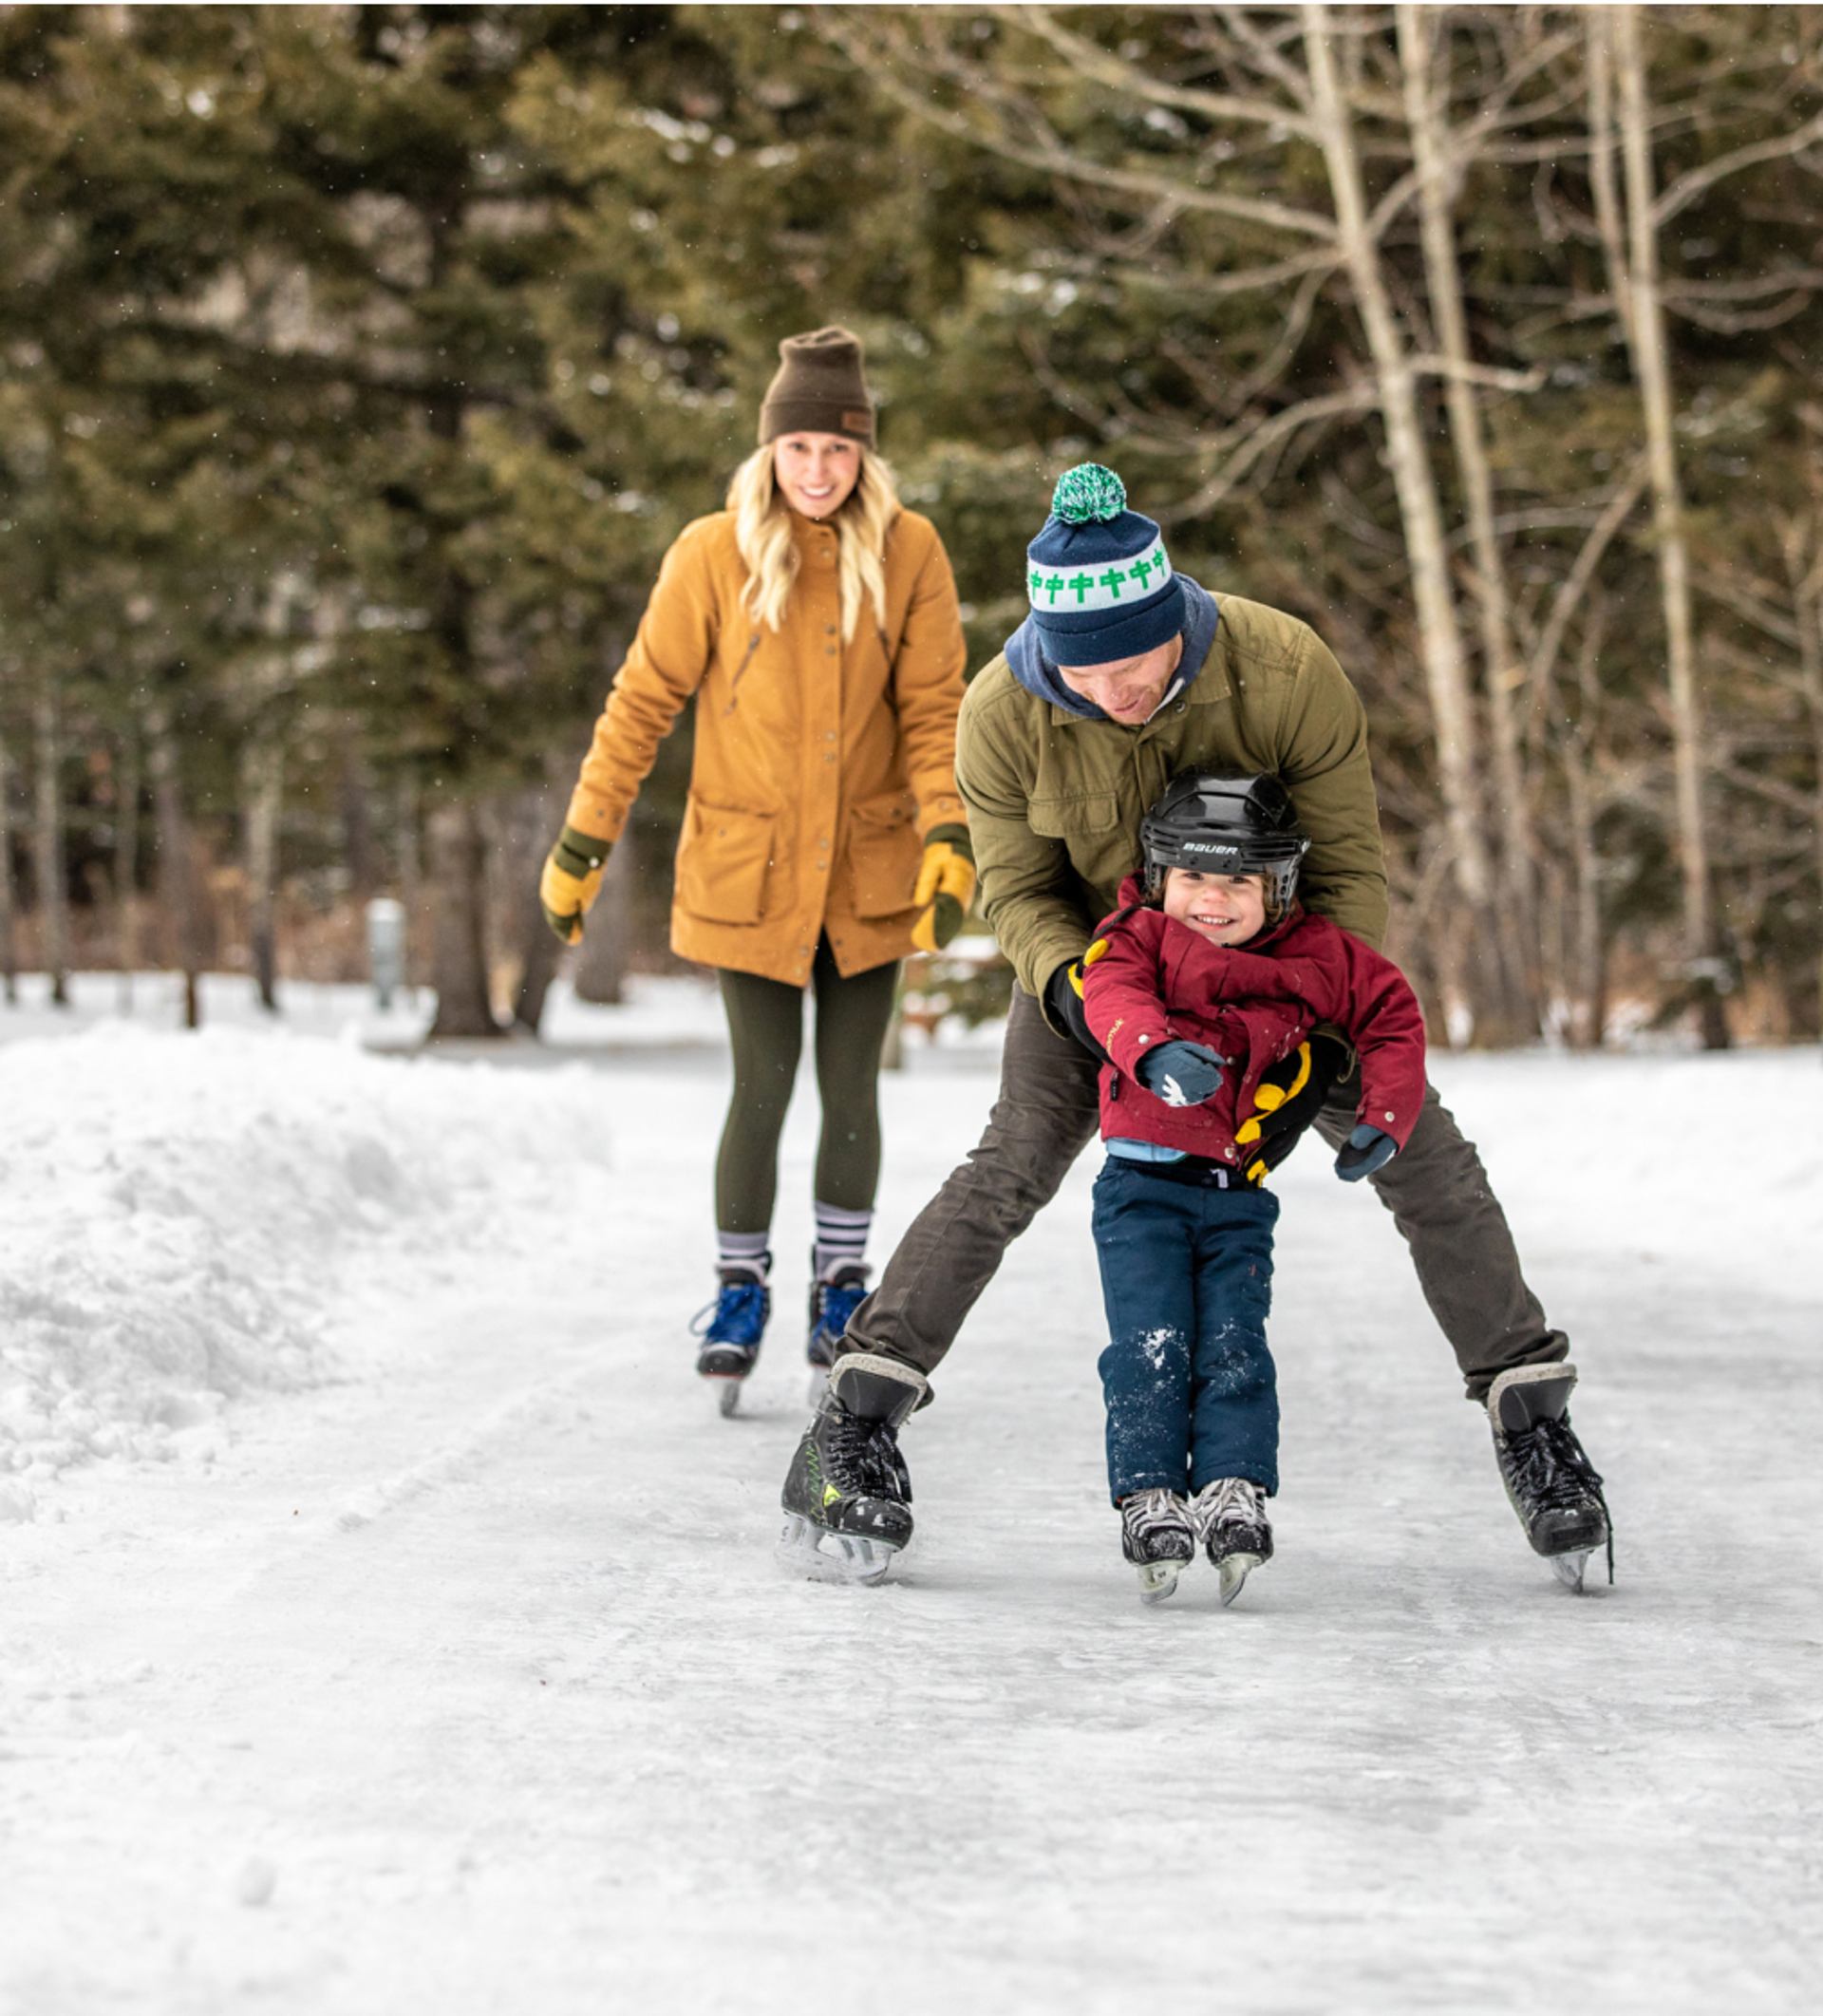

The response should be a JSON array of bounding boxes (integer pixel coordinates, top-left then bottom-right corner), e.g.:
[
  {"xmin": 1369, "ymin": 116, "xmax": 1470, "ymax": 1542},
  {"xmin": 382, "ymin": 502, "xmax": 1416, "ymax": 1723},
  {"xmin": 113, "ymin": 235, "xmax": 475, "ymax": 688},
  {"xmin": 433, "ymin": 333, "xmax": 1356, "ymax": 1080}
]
[{"xmin": 567, "ymin": 510, "xmax": 964, "ymax": 986}]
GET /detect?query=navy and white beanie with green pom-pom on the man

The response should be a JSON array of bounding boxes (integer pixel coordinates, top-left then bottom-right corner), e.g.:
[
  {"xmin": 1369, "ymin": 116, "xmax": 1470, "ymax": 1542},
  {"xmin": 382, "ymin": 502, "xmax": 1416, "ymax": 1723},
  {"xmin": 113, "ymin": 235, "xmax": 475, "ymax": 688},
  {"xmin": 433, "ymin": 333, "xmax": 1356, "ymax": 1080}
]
[{"xmin": 1026, "ymin": 462, "xmax": 1184, "ymax": 666}]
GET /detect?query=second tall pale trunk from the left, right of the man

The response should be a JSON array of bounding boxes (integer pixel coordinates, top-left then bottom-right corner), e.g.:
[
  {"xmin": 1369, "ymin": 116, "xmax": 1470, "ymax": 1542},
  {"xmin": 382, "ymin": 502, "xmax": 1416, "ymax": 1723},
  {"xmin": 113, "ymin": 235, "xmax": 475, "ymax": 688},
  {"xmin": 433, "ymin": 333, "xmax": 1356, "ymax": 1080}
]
[{"xmin": 1398, "ymin": 15, "xmax": 1539, "ymax": 1040}]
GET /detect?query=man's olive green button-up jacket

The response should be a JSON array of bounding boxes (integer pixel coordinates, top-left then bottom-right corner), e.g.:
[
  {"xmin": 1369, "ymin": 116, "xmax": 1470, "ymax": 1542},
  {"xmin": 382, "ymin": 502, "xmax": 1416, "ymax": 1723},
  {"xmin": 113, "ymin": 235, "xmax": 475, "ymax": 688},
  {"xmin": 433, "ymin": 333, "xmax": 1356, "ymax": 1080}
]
[{"xmin": 956, "ymin": 594, "xmax": 1385, "ymax": 1024}]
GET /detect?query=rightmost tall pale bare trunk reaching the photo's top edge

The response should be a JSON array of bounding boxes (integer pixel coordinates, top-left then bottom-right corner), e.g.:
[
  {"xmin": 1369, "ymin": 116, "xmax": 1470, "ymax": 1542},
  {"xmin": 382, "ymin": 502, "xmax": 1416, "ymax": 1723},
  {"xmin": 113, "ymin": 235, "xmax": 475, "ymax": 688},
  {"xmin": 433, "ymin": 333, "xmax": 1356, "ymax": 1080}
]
[{"xmin": 1611, "ymin": 6, "xmax": 1728, "ymax": 1050}]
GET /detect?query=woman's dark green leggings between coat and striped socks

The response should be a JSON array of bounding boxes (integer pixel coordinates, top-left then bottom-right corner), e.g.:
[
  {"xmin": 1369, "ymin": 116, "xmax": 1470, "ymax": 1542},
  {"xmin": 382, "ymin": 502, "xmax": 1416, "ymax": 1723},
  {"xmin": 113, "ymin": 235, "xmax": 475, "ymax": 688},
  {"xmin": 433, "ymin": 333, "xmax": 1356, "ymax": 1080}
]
[{"xmin": 716, "ymin": 937, "xmax": 899, "ymax": 1232}]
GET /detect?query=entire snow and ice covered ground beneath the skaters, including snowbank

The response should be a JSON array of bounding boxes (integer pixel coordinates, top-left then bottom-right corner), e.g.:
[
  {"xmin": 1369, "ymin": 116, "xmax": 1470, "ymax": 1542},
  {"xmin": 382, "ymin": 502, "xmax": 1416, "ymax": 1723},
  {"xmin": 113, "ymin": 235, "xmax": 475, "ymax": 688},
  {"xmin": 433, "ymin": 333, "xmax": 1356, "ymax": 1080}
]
[{"xmin": 0, "ymin": 984, "xmax": 1823, "ymax": 2016}]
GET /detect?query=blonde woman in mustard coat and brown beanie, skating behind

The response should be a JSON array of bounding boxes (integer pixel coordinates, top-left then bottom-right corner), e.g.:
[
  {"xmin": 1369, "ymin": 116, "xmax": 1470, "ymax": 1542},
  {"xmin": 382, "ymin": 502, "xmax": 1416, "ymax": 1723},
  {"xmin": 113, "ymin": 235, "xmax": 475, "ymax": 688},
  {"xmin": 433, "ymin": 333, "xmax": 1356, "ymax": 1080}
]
[{"xmin": 540, "ymin": 329, "xmax": 974, "ymax": 1413}]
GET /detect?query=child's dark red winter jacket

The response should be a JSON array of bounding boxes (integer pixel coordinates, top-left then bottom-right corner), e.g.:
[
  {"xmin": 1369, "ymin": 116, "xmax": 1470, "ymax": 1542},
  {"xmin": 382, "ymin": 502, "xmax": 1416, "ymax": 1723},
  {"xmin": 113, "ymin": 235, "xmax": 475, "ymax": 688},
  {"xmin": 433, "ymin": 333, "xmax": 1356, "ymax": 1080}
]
[{"xmin": 1083, "ymin": 877, "xmax": 1423, "ymax": 1165}]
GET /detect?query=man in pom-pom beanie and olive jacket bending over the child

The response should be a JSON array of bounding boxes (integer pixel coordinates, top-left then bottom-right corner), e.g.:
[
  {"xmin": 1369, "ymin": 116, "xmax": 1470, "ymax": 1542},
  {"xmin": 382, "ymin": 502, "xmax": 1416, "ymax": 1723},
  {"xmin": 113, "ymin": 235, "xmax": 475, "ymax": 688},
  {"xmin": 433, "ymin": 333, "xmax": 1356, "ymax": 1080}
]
[{"xmin": 782, "ymin": 463, "xmax": 1611, "ymax": 1587}]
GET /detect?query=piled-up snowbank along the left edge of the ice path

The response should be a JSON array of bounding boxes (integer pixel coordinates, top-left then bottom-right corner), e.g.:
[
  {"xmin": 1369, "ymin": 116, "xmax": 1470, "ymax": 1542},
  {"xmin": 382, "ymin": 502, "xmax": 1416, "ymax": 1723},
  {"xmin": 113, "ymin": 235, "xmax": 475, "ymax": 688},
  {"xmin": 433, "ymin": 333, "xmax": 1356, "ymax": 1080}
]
[{"xmin": 0, "ymin": 1024, "xmax": 605, "ymax": 1492}]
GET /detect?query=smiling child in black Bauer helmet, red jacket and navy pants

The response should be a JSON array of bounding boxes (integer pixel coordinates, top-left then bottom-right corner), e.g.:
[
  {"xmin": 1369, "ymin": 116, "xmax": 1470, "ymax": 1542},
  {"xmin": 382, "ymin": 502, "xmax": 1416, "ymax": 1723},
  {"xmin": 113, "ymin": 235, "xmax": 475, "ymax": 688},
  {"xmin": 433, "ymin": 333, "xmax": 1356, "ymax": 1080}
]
[{"xmin": 1083, "ymin": 772, "xmax": 1423, "ymax": 1603}]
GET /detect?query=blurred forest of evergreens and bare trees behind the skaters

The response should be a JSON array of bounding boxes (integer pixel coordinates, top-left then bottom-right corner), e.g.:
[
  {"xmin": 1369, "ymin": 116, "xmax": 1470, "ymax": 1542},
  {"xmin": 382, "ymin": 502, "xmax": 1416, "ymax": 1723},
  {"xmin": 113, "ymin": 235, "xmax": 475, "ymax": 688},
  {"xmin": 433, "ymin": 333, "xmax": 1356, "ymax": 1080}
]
[{"xmin": 0, "ymin": 6, "xmax": 1823, "ymax": 1046}]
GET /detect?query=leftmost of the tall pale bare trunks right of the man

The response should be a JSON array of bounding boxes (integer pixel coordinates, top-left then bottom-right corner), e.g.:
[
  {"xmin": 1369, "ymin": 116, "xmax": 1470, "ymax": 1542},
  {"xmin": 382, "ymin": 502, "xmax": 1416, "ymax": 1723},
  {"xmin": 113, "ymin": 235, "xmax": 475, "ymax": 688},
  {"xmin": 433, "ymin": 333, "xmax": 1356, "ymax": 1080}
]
[{"xmin": 1303, "ymin": 6, "xmax": 1504, "ymax": 1047}]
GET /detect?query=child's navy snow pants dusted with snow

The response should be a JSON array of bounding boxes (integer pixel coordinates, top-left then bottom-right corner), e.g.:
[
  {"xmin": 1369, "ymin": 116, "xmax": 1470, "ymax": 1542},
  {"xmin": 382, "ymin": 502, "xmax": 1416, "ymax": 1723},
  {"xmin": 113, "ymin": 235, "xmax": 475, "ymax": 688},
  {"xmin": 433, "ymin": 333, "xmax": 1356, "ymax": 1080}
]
[{"xmin": 1095, "ymin": 1155, "xmax": 1279, "ymax": 1504}]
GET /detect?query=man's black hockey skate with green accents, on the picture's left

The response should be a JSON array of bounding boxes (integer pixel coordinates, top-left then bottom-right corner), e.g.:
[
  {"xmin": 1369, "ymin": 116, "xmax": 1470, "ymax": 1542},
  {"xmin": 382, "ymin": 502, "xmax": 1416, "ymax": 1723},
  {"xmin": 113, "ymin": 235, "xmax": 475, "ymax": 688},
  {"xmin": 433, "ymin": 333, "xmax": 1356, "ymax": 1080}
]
[{"xmin": 779, "ymin": 1350, "xmax": 924, "ymax": 1583}]
